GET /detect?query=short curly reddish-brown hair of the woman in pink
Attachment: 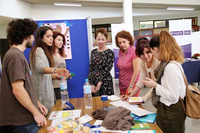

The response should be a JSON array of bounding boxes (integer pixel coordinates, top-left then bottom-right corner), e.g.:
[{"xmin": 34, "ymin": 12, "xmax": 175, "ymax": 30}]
[{"xmin": 115, "ymin": 30, "xmax": 134, "ymax": 48}]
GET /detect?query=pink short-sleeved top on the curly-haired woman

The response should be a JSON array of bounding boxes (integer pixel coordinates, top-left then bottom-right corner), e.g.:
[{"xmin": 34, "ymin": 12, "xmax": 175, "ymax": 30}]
[{"xmin": 117, "ymin": 46, "xmax": 139, "ymax": 90}]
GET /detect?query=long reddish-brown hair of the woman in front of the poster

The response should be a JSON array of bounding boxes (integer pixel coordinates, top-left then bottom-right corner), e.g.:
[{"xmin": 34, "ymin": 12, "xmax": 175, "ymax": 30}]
[{"xmin": 52, "ymin": 31, "xmax": 67, "ymax": 57}]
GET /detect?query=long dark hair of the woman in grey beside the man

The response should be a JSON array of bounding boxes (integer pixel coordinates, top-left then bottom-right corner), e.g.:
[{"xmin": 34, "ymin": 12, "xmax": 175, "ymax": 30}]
[{"xmin": 30, "ymin": 26, "xmax": 54, "ymax": 69}]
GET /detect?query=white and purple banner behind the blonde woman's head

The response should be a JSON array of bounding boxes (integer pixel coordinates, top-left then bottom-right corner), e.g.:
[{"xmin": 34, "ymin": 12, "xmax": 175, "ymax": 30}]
[{"xmin": 169, "ymin": 19, "xmax": 192, "ymax": 58}]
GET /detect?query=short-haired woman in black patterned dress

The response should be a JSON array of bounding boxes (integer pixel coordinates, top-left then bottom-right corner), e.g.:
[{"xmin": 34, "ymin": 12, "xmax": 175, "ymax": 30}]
[{"xmin": 88, "ymin": 29, "xmax": 115, "ymax": 96}]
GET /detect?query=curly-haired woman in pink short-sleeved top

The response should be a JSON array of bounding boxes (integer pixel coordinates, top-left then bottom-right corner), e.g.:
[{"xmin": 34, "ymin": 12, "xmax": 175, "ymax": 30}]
[{"xmin": 115, "ymin": 30, "xmax": 140, "ymax": 96}]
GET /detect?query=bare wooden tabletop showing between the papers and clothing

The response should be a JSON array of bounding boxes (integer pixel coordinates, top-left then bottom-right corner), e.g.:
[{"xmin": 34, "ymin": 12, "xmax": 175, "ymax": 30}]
[{"xmin": 38, "ymin": 97, "xmax": 163, "ymax": 133}]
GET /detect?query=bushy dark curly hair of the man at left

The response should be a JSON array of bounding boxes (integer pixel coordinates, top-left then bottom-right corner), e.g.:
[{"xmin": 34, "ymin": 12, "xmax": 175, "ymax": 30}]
[{"xmin": 7, "ymin": 18, "xmax": 38, "ymax": 45}]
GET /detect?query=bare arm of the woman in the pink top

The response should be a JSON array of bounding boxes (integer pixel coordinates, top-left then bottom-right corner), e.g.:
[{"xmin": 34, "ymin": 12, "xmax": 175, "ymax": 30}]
[{"xmin": 128, "ymin": 58, "xmax": 140, "ymax": 94}]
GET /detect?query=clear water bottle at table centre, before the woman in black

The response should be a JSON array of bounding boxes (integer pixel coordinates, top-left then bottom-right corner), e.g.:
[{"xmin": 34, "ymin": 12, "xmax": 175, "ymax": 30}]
[{"xmin": 83, "ymin": 79, "xmax": 92, "ymax": 108}]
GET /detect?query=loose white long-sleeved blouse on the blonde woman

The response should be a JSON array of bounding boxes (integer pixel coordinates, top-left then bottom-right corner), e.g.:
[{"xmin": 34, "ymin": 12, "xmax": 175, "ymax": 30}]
[{"xmin": 156, "ymin": 61, "xmax": 186, "ymax": 106}]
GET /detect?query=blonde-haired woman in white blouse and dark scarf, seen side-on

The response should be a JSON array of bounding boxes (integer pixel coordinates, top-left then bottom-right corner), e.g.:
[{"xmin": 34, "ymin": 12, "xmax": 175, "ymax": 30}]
[{"xmin": 143, "ymin": 31, "xmax": 186, "ymax": 133}]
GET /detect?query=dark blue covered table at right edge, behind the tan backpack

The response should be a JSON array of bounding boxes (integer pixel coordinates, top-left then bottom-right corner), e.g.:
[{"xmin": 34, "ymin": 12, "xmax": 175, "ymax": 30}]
[{"xmin": 182, "ymin": 60, "xmax": 200, "ymax": 83}]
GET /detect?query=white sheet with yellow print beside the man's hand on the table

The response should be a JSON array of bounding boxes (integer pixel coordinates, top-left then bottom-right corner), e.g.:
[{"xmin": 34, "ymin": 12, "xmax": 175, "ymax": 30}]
[{"xmin": 49, "ymin": 109, "xmax": 81, "ymax": 120}]
